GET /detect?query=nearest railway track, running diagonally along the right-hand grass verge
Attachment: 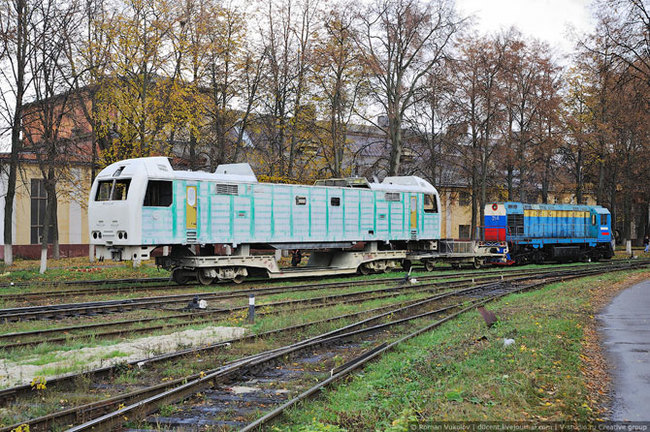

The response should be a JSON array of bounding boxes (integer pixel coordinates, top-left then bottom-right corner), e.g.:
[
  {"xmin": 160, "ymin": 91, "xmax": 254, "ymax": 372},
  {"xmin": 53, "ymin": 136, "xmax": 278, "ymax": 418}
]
[{"xmin": 5, "ymin": 265, "xmax": 638, "ymax": 430}]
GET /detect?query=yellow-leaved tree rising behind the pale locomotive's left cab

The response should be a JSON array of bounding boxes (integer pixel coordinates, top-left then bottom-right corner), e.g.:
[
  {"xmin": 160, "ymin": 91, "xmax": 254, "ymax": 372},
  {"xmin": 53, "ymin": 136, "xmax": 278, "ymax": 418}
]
[{"xmin": 97, "ymin": 0, "xmax": 195, "ymax": 163}]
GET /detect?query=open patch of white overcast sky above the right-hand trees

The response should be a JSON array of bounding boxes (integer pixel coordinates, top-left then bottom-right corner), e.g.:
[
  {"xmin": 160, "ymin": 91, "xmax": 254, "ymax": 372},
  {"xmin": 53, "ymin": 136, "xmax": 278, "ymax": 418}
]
[{"xmin": 456, "ymin": 0, "xmax": 595, "ymax": 54}]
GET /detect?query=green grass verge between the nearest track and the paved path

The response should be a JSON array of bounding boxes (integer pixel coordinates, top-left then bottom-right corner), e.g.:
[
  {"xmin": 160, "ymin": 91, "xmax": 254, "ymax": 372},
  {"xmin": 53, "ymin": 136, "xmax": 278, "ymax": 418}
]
[{"xmin": 276, "ymin": 272, "xmax": 648, "ymax": 431}]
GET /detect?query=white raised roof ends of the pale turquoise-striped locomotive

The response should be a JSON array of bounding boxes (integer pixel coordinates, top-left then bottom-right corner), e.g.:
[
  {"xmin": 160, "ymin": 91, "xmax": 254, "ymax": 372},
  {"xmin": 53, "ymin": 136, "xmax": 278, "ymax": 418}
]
[{"xmin": 97, "ymin": 156, "xmax": 437, "ymax": 194}]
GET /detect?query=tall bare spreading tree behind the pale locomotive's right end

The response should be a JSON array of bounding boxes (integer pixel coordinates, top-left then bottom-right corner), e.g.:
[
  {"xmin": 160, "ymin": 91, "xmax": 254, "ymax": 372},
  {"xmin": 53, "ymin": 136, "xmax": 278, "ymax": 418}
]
[{"xmin": 357, "ymin": 0, "xmax": 460, "ymax": 175}]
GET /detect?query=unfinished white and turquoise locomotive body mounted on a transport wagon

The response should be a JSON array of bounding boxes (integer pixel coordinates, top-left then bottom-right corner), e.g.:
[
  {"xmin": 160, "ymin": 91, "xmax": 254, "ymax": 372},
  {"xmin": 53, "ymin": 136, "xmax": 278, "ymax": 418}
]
[{"xmin": 88, "ymin": 157, "xmax": 440, "ymax": 283}]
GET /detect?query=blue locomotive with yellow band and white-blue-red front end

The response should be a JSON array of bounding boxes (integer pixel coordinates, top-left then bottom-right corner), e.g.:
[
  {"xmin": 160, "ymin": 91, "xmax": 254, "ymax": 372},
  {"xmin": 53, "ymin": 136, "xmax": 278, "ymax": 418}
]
[{"xmin": 484, "ymin": 202, "xmax": 614, "ymax": 263}]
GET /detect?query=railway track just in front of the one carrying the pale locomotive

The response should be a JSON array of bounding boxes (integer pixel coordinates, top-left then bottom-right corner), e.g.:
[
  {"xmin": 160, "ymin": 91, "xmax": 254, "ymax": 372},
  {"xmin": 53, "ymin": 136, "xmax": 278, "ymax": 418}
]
[{"xmin": 0, "ymin": 262, "xmax": 632, "ymax": 322}]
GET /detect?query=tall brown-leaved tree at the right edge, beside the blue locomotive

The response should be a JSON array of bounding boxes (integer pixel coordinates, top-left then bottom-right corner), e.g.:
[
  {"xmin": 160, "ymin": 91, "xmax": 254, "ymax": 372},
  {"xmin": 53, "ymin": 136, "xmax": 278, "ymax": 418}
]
[{"xmin": 576, "ymin": 1, "xmax": 650, "ymax": 243}]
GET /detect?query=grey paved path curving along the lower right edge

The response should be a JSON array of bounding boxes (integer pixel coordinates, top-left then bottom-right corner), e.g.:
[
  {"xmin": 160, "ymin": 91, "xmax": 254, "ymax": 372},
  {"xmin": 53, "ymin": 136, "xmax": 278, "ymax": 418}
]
[{"xmin": 598, "ymin": 280, "xmax": 650, "ymax": 421}]
